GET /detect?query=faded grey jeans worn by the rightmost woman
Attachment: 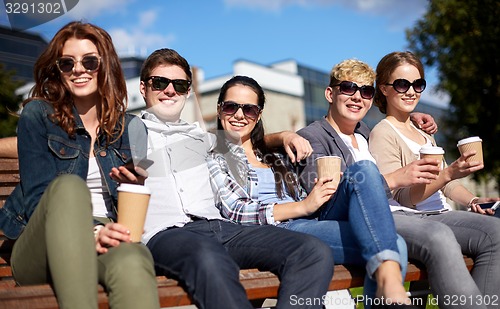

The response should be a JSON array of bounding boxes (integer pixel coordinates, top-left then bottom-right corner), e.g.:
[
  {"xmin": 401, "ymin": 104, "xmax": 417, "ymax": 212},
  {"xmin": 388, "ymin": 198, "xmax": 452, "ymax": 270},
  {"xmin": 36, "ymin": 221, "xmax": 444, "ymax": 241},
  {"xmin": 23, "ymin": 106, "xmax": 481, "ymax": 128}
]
[{"xmin": 394, "ymin": 211, "xmax": 500, "ymax": 309}]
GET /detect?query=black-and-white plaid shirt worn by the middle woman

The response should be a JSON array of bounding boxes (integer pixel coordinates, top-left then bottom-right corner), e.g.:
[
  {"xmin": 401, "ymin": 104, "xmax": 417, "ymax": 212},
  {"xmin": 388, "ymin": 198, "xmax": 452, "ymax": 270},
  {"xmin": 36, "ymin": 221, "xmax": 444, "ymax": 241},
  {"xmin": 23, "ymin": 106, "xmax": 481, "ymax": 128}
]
[{"xmin": 207, "ymin": 142, "xmax": 306, "ymax": 225}]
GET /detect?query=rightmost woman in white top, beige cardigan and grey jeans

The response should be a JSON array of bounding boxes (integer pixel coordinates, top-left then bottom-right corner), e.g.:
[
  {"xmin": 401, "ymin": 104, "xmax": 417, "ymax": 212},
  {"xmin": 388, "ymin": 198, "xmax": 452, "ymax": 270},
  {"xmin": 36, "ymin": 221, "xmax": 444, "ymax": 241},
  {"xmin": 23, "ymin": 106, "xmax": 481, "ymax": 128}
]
[{"xmin": 369, "ymin": 52, "xmax": 500, "ymax": 308}]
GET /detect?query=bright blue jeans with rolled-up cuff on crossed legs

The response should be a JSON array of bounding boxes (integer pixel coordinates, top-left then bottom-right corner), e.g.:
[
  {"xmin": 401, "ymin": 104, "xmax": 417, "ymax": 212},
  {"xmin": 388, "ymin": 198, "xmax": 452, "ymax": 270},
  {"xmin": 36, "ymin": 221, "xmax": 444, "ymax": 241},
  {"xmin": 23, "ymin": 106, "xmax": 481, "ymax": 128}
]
[{"xmin": 280, "ymin": 161, "xmax": 408, "ymax": 306}]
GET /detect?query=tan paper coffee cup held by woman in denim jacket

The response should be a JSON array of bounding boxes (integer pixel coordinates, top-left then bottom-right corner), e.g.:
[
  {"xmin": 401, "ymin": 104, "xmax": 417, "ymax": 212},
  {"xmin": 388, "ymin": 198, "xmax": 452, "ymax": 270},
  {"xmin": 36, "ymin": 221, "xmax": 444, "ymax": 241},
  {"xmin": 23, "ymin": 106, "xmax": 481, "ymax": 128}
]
[{"xmin": 118, "ymin": 184, "xmax": 151, "ymax": 242}]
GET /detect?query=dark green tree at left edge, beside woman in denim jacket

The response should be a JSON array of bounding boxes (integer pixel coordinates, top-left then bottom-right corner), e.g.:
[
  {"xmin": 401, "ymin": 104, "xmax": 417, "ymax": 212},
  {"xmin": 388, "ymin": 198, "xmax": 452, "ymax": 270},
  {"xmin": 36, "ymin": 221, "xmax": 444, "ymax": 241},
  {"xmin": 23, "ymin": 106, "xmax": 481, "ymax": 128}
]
[{"xmin": 0, "ymin": 63, "xmax": 22, "ymax": 137}]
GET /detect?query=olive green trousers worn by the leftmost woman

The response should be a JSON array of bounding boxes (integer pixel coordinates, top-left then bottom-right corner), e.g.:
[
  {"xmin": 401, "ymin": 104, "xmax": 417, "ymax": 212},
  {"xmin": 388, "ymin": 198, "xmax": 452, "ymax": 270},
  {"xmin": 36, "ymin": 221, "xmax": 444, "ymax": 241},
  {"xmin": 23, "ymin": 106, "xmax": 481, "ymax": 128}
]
[{"xmin": 11, "ymin": 175, "xmax": 160, "ymax": 309}]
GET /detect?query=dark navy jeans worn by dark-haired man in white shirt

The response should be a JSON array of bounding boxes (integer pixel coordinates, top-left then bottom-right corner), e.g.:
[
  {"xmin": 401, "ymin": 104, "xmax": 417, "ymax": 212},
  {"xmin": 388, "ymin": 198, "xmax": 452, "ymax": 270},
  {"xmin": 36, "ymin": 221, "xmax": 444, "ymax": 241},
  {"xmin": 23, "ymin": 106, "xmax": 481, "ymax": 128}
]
[{"xmin": 147, "ymin": 220, "xmax": 333, "ymax": 309}]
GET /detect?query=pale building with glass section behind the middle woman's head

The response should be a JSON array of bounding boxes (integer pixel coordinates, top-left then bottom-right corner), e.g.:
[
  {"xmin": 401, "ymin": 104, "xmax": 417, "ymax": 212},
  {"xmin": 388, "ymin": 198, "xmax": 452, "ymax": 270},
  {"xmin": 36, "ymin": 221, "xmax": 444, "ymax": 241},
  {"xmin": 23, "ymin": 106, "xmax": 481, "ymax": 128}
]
[{"xmin": 198, "ymin": 60, "xmax": 444, "ymax": 145}]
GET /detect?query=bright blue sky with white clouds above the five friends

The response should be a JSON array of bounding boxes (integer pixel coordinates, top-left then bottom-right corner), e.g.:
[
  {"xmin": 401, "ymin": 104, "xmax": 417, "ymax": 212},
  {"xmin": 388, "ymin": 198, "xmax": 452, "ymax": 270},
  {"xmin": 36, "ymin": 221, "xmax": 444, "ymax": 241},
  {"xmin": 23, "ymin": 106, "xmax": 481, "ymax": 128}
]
[{"xmin": 0, "ymin": 0, "xmax": 446, "ymax": 104}]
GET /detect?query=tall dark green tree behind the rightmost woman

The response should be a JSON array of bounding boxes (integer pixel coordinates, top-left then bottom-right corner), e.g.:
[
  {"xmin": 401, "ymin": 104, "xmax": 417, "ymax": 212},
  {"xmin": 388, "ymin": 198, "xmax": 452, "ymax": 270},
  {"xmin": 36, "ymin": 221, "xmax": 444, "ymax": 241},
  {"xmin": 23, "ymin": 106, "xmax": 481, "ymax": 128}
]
[{"xmin": 406, "ymin": 0, "xmax": 500, "ymax": 190}]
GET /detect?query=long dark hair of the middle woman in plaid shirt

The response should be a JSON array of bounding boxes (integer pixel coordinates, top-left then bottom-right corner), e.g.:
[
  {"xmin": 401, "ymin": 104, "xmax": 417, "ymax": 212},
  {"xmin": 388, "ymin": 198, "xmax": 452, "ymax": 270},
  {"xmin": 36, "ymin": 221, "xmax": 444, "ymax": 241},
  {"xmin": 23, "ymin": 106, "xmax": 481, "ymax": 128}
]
[{"xmin": 216, "ymin": 75, "xmax": 298, "ymax": 198}]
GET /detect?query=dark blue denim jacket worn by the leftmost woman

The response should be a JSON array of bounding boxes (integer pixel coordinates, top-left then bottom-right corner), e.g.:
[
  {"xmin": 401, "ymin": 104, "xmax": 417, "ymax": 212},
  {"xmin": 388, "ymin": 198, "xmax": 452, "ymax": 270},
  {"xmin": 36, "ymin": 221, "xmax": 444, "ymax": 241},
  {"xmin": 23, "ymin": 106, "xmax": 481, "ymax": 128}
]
[{"xmin": 0, "ymin": 100, "xmax": 147, "ymax": 239}]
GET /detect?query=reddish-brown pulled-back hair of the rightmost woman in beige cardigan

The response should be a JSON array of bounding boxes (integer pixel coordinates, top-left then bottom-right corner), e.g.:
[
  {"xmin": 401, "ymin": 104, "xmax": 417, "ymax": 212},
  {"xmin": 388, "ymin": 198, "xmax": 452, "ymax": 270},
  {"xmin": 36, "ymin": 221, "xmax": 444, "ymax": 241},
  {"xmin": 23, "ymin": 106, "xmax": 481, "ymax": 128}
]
[{"xmin": 373, "ymin": 51, "xmax": 425, "ymax": 114}]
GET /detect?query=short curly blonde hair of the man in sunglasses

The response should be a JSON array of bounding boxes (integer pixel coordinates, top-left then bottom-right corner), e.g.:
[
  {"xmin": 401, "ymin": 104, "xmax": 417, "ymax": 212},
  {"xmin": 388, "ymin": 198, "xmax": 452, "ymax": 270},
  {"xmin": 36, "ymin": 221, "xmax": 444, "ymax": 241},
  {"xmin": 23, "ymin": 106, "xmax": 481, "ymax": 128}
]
[{"xmin": 329, "ymin": 59, "xmax": 375, "ymax": 87}]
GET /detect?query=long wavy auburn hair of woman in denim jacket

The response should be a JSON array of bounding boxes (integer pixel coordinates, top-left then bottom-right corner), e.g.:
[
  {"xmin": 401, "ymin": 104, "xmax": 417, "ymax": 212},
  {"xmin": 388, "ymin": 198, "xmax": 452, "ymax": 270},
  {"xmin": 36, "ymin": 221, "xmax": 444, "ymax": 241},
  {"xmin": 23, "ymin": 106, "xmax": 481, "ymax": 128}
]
[{"xmin": 23, "ymin": 21, "xmax": 128, "ymax": 144}]
